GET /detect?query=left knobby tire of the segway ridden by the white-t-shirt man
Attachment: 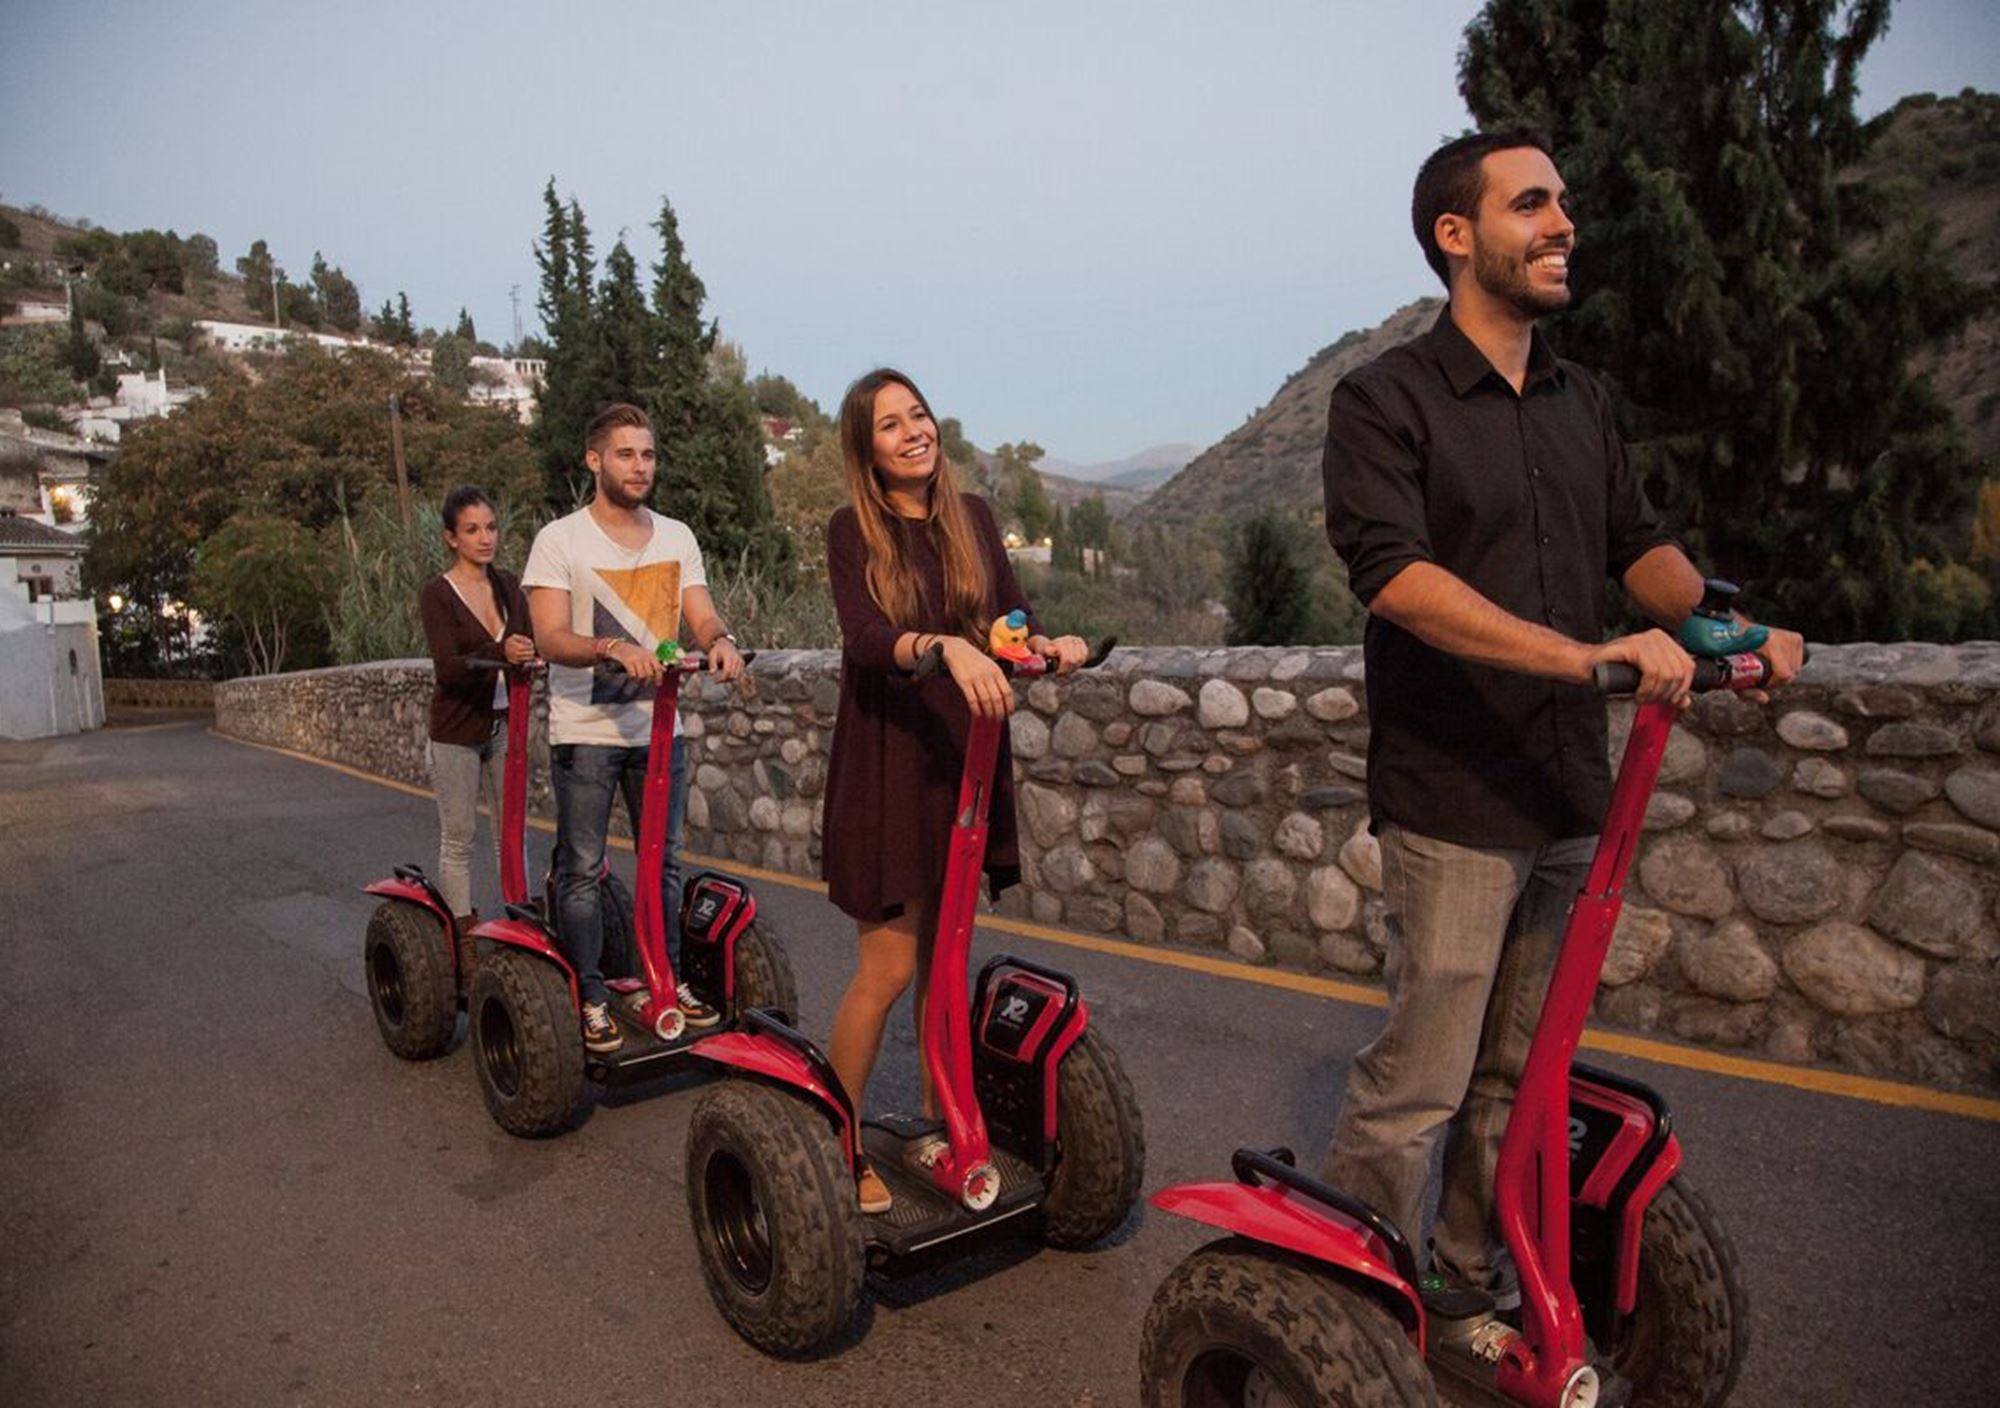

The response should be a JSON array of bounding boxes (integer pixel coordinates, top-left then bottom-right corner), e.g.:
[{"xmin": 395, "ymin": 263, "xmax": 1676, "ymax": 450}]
[{"xmin": 468, "ymin": 946, "xmax": 584, "ymax": 1138}]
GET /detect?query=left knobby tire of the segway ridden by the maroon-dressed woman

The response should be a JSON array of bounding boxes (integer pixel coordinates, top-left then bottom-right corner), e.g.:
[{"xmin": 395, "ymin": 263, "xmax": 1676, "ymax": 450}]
[{"xmin": 688, "ymin": 1080, "xmax": 866, "ymax": 1358}]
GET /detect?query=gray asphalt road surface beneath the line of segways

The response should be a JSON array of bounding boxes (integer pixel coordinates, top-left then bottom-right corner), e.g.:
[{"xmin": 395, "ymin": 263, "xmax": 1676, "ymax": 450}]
[{"xmin": 0, "ymin": 720, "xmax": 2000, "ymax": 1408}]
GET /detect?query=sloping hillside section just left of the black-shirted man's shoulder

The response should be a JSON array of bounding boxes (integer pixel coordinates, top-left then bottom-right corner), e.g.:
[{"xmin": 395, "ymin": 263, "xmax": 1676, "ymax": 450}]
[{"xmin": 1132, "ymin": 298, "xmax": 1444, "ymax": 524}]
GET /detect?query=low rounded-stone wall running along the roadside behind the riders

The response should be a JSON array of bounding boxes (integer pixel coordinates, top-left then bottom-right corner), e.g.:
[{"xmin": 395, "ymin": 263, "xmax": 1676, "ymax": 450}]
[{"xmin": 216, "ymin": 644, "xmax": 2000, "ymax": 1090}]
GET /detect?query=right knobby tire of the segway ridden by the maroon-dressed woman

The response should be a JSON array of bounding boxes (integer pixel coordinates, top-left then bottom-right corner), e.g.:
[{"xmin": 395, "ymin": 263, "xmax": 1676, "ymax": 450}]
[{"xmin": 1042, "ymin": 1026, "xmax": 1146, "ymax": 1248}]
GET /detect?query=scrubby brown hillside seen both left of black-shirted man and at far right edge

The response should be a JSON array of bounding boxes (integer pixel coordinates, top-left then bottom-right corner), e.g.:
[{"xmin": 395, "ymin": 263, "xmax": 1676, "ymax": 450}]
[{"xmin": 1132, "ymin": 92, "xmax": 2000, "ymax": 524}]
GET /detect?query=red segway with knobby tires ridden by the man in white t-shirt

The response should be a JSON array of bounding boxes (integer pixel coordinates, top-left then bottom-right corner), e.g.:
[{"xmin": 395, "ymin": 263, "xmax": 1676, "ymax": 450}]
[{"xmin": 468, "ymin": 652, "xmax": 798, "ymax": 1138}]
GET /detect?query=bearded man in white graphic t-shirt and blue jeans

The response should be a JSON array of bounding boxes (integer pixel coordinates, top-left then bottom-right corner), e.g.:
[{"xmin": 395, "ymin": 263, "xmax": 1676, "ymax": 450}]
[{"xmin": 520, "ymin": 404, "xmax": 744, "ymax": 1052}]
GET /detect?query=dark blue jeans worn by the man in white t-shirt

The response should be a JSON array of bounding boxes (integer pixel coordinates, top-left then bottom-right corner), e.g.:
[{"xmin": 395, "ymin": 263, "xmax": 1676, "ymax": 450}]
[{"xmin": 548, "ymin": 738, "xmax": 688, "ymax": 1002}]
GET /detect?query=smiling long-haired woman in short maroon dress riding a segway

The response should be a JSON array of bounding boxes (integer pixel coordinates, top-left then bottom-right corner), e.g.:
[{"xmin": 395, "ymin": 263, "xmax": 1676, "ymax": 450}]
[{"xmin": 822, "ymin": 368, "xmax": 1088, "ymax": 1212}]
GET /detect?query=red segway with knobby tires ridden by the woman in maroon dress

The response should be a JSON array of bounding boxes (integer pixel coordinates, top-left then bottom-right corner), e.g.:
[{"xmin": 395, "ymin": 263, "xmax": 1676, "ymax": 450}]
[{"xmin": 688, "ymin": 628, "xmax": 1146, "ymax": 1356}]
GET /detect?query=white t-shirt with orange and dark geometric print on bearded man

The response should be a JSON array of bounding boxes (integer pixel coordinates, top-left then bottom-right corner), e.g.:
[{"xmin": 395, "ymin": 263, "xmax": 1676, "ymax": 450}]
[{"xmin": 520, "ymin": 508, "xmax": 708, "ymax": 748}]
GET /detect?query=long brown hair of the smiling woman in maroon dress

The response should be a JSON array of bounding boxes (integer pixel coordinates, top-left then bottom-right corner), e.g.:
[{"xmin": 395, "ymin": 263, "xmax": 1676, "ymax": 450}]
[{"xmin": 840, "ymin": 366, "xmax": 988, "ymax": 644}]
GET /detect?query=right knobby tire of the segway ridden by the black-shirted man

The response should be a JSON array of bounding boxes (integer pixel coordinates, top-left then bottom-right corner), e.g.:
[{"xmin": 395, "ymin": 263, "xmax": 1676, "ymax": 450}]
[{"xmin": 1612, "ymin": 1176, "xmax": 1750, "ymax": 1408}]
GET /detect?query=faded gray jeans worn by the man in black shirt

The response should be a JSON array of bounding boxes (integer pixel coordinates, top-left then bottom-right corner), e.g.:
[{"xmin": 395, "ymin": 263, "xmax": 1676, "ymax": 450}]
[{"xmin": 1324, "ymin": 826, "xmax": 1596, "ymax": 1286}]
